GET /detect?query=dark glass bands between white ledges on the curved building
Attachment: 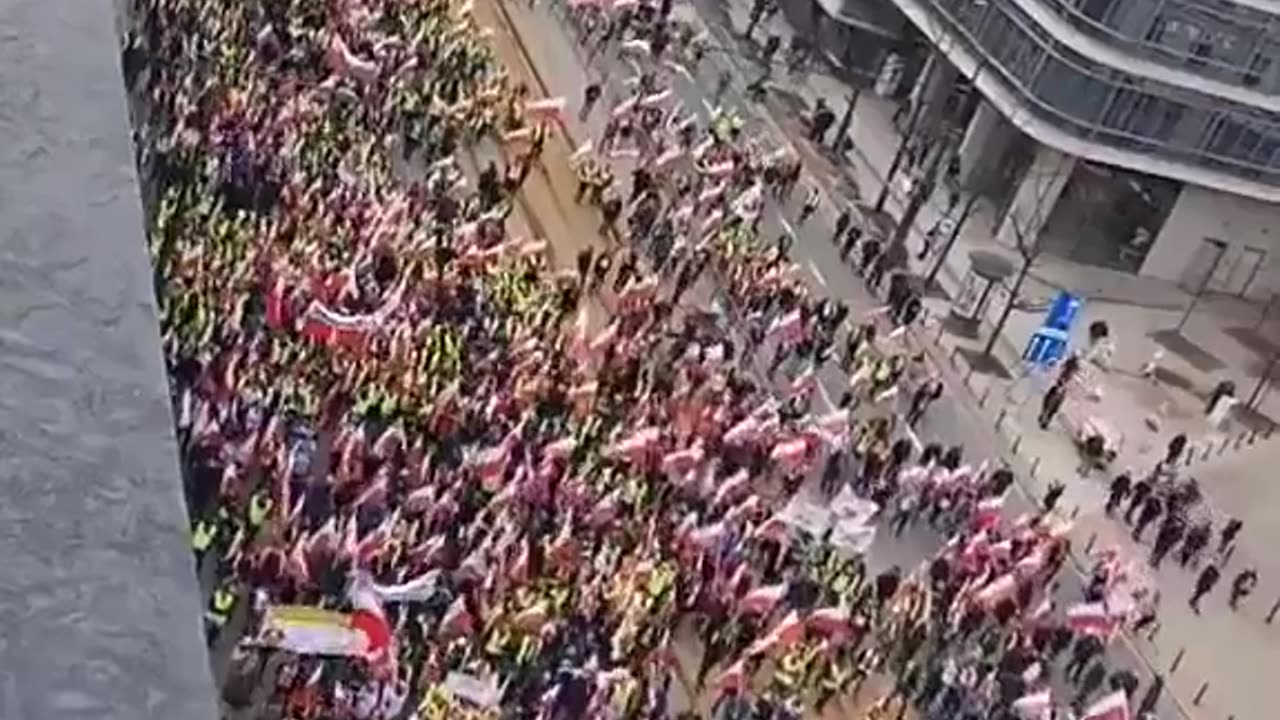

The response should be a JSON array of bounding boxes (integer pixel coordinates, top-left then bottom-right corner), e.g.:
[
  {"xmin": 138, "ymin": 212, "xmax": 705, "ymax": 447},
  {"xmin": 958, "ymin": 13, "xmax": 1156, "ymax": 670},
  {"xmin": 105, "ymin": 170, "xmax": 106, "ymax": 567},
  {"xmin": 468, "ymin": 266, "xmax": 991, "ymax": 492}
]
[{"xmin": 923, "ymin": 0, "xmax": 1280, "ymax": 184}]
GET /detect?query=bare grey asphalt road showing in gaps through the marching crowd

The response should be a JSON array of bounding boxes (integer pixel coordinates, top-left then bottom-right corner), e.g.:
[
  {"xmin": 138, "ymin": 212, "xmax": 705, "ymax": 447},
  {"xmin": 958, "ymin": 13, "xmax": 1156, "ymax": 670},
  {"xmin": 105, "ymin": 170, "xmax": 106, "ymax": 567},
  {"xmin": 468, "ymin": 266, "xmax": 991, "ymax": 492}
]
[{"xmin": 496, "ymin": 0, "xmax": 1185, "ymax": 720}]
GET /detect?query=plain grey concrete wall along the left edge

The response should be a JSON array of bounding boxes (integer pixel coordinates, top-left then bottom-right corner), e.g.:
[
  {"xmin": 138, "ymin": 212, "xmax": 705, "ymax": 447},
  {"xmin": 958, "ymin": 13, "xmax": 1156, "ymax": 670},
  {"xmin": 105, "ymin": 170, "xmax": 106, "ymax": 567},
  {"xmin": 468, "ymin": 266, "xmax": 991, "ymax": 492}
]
[{"xmin": 0, "ymin": 0, "xmax": 216, "ymax": 720}]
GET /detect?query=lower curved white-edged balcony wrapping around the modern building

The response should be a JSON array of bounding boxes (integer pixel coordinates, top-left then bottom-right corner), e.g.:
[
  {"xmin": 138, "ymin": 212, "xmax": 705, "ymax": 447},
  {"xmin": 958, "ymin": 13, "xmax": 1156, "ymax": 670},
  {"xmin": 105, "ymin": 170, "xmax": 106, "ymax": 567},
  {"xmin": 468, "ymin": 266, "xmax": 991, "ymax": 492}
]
[{"xmin": 893, "ymin": 0, "xmax": 1280, "ymax": 201}]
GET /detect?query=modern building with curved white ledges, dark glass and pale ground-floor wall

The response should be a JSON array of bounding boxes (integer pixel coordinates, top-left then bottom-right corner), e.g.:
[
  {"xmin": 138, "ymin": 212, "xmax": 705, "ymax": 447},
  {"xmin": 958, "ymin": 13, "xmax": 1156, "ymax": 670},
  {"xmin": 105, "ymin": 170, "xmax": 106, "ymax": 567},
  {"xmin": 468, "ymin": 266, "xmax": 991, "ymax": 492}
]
[{"xmin": 884, "ymin": 0, "xmax": 1280, "ymax": 296}]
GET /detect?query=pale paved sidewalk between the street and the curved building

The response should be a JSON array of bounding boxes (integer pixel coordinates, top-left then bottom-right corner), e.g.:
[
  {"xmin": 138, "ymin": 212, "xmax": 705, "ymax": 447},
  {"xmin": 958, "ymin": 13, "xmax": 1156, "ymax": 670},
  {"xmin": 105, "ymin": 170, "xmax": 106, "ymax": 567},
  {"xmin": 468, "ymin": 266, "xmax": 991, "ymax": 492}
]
[{"xmin": 691, "ymin": 0, "xmax": 1280, "ymax": 720}]
